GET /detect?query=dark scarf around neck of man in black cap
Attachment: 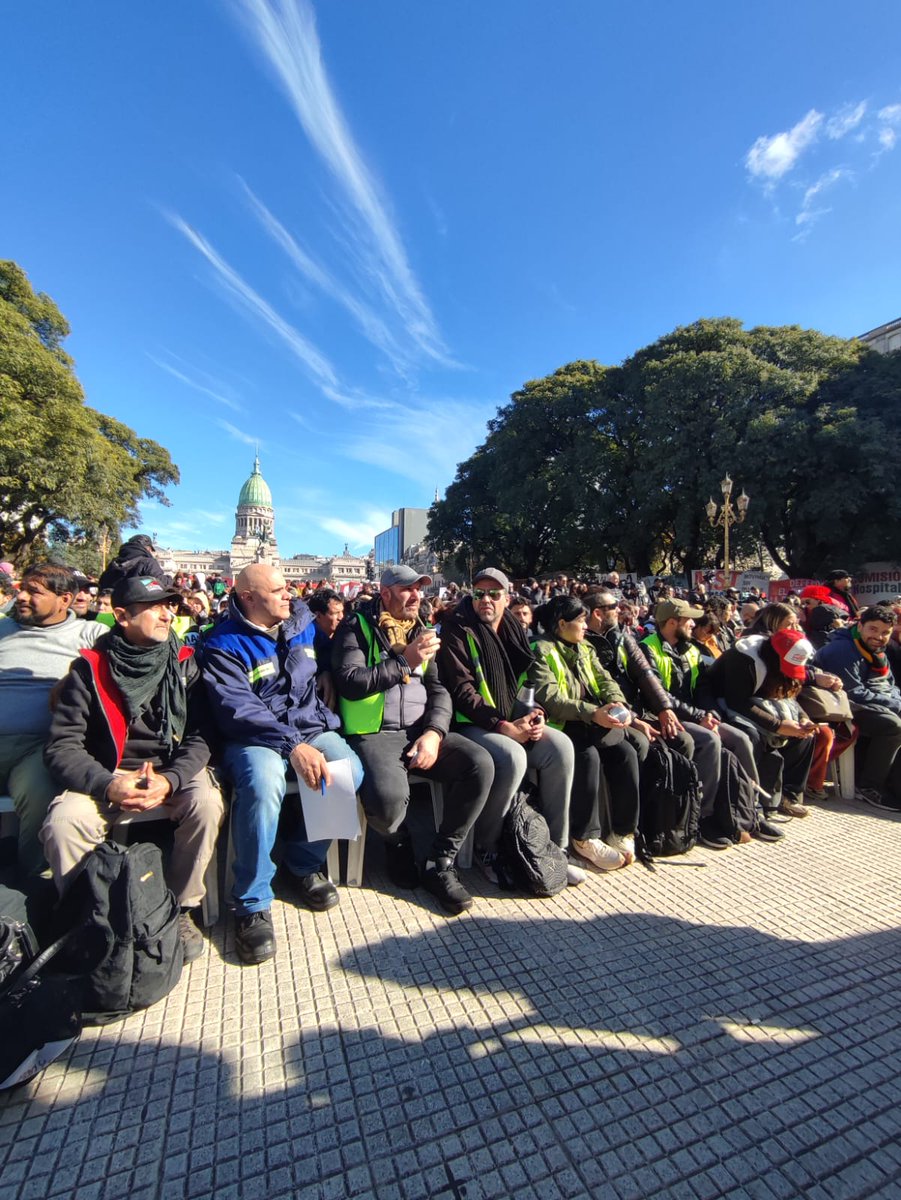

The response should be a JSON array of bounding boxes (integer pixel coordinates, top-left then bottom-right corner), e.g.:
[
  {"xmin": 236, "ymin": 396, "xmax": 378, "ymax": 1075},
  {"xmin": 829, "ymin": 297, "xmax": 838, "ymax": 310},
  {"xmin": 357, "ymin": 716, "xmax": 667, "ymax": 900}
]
[{"xmin": 97, "ymin": 625, "xmax": 187, "ymax": 752}]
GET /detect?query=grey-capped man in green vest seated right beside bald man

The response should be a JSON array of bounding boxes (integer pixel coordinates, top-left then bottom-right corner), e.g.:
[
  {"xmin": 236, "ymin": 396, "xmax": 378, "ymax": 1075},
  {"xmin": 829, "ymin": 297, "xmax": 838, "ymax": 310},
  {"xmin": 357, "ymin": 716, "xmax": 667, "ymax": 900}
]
[{"xmin": 332, "ymin": 566, "xmax": 494, "ymax": 914}]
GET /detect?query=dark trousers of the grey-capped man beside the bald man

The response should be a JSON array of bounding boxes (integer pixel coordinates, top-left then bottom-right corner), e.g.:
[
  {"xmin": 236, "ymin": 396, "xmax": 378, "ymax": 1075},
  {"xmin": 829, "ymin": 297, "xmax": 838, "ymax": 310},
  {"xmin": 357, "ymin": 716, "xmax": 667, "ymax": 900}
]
[{"xmin": 347, "ymin": 730, "xmax": 494, "ymax": 859}]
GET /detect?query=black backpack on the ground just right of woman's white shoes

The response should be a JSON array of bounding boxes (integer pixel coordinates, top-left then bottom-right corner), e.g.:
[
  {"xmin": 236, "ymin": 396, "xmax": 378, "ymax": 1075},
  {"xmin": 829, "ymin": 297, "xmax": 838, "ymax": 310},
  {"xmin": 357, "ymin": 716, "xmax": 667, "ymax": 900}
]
[{"xmin": 638, "ymin": 738, "xmax": 701, "ymax": 858}]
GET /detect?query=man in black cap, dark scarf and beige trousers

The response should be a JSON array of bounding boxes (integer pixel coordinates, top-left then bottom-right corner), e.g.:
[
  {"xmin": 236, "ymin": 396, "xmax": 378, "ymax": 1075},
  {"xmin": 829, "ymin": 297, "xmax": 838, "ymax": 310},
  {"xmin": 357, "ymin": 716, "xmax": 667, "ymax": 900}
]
[{"xmin": 41, "ymin": 576, "xmax": 223, "ymax": 962}]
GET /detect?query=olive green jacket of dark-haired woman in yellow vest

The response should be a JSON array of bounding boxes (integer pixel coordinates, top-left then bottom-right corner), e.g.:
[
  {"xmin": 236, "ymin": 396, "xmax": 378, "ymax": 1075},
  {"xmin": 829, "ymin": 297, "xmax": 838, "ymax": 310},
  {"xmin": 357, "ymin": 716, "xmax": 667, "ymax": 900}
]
[{"xmin": 529, "ymin": 638, "xmax": 626, "ymax": 727}]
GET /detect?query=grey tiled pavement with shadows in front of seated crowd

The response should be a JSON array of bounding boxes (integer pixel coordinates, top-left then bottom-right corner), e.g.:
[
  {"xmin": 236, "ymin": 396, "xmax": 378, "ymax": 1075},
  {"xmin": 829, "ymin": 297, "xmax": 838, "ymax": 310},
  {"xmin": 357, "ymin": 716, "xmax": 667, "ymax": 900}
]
[{"xmin": 0, "ymin": 804, "xmax": 901, "ymax": 1200}]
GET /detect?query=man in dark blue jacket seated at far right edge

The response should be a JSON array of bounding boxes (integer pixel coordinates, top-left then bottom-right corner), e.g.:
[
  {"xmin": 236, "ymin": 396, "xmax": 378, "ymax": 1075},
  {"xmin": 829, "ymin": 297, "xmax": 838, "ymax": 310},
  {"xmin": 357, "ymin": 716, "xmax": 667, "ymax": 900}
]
[{"xmin": 813, "ymin": 605, "xmax": 901, "ymax": 812}]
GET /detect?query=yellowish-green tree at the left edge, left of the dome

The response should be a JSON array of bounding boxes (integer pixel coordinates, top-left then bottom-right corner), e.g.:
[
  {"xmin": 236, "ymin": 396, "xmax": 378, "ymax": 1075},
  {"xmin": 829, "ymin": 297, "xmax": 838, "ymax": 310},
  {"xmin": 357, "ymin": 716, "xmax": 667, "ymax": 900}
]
[{"xmin": 0, "ymin": 262, "xmax": 179, "ymax": 566}]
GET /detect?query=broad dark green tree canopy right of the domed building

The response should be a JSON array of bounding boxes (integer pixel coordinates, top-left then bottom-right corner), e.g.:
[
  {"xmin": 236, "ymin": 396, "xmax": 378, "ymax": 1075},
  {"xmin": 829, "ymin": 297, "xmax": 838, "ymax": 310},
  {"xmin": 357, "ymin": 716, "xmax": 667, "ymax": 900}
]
[{"xmin": 430, "ymin": 318, "xmax": 901, "ymax": 576}]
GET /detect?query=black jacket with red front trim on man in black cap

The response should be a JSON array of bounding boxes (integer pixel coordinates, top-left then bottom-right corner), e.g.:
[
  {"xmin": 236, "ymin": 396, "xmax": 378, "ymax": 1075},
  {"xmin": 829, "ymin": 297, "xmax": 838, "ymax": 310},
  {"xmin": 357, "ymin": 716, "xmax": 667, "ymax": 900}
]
[{"xmin": 44, "ymin": 638, "xmax": 210, "ymax": 800}]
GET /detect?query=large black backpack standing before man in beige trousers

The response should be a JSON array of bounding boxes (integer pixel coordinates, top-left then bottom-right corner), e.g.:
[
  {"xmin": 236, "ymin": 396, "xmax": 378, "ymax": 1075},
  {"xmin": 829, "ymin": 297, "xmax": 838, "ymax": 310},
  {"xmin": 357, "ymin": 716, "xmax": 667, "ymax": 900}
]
[{"xmin": 58, "ymin": 841, "xmax": 184, "ymax": 1025}]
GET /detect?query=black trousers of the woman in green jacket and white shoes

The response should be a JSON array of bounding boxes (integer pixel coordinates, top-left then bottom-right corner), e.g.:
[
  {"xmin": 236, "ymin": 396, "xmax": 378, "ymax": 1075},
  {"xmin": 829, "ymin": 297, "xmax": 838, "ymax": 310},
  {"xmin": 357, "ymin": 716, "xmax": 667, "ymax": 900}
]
[{"xmin": 564, "ymin": 721, "xmax": 648, "ymax": 841}]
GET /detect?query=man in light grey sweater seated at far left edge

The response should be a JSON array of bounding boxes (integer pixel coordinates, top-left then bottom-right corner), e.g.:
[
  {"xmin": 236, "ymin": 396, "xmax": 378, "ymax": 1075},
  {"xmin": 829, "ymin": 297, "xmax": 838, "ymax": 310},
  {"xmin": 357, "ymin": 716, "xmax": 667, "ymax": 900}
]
[{"xmin": 0, "ymin": 563, "xmax": 104, "ymax": 876}]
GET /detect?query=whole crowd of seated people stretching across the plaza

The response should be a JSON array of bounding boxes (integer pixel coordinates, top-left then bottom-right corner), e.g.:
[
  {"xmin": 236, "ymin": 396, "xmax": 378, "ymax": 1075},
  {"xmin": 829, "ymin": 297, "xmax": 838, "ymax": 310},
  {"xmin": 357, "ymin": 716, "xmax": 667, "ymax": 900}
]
[{"xmin": 0, "ymin": 536, "xmax": 901, "ymax": 964}]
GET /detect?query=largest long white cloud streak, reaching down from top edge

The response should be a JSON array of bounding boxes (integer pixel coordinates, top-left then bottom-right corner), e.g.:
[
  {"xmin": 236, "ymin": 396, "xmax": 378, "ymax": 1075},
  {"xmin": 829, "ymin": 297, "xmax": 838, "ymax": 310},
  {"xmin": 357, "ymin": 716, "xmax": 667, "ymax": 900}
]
[{"xmin": 234, "ymin": 0, "xmax": 448, "ymax": 362}]
